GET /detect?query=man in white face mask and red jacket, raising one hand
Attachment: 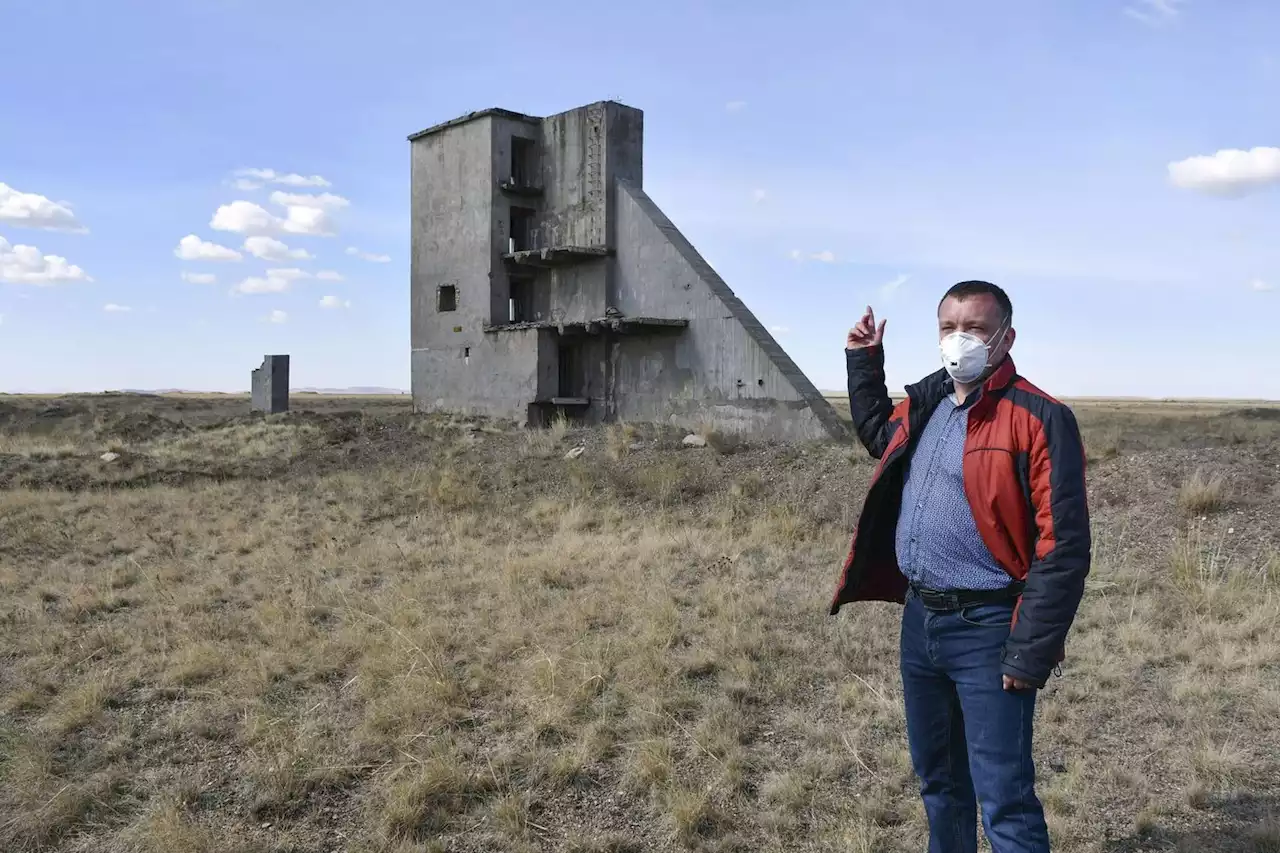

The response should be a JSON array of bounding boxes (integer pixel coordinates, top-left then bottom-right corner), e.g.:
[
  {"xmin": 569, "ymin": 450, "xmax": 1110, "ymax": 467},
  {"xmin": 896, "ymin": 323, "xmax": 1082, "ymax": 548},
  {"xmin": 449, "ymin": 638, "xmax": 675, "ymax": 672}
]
[{"xmin": 831, "ymin": 282, "xmax": 1091, "ymax": 853}]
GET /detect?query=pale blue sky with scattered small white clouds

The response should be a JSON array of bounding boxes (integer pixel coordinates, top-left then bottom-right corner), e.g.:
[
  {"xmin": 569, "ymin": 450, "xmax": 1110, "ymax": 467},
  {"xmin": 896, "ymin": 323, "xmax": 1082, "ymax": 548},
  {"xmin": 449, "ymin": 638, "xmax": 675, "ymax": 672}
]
[{"xmin": 0, "ymin": 0, "xmax": 1280, "ymax": 398}]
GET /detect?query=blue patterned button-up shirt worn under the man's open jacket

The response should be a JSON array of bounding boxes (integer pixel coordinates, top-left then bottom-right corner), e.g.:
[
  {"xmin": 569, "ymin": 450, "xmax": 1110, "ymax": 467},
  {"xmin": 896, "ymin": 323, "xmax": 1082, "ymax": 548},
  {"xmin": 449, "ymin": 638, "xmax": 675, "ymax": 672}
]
[{"xmin": 896, "ymin": 393, "xmax": 1011, "ymax": 590}]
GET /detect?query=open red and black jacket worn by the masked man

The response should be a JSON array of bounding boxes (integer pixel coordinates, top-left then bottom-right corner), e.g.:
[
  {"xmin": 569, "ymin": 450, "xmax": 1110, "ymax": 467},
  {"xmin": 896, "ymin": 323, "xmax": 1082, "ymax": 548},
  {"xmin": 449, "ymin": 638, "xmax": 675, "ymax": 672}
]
[{"xmin": 831, "ymin": 346, "xmax": 1092, "ymax": 686}]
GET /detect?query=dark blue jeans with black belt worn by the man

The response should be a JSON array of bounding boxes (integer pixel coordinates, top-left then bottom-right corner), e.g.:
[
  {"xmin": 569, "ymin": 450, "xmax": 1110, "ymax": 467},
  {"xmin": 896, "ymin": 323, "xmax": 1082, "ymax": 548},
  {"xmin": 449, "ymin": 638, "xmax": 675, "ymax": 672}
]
[{"xmin": 901, "ymin": 592, "xmax": 1048, "ymax": 853}]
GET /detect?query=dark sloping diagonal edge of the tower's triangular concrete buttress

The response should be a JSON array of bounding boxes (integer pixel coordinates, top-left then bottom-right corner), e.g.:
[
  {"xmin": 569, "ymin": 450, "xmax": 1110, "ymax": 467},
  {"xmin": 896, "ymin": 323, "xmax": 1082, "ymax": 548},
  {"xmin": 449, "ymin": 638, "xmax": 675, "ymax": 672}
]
[{"xmin": 617, "ymin": 181, "xmax": 850, "ymax": 439}]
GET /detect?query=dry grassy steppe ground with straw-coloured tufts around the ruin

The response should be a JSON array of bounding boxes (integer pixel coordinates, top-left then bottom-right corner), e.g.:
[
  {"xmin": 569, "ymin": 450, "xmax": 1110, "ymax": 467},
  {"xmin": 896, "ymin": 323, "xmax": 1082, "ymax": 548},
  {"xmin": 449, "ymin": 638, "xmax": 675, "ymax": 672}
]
[{"xmin": 0, "ymin": 396, "xmax": 1280, "ymax": 853}]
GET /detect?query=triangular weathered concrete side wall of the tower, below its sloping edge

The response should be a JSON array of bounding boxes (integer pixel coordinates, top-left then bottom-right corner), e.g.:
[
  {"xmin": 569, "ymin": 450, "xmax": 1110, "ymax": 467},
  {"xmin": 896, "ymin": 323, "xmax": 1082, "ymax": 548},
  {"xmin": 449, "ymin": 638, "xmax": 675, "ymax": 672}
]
[{"xmin": 613, "ymin": 183, "xmax": 845, "ymax": 439}]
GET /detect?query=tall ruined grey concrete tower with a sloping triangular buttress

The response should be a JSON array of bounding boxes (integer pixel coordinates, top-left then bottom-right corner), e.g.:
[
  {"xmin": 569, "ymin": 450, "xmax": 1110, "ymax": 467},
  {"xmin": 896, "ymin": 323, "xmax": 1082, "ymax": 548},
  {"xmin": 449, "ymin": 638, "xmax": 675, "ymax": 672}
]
[{"xmin": 410, "ymin": 101, "xmax": 845, "ymax": 439}]
